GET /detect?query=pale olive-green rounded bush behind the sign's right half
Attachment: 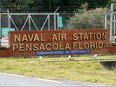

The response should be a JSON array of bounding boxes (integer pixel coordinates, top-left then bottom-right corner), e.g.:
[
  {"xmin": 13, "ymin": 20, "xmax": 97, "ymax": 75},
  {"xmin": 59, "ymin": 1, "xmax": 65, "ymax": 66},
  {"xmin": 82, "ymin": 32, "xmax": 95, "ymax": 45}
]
[{"xmin": 67, "ymin": 8, "xmax": 105, "ymax": 29}]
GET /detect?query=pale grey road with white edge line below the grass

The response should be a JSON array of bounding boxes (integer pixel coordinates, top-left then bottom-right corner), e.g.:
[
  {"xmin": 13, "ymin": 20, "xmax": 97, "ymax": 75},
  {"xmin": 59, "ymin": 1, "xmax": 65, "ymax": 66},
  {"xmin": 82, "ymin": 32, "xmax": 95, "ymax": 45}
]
[{"xmin": 0, "ymin": 73, "xmax": 116, "ymax": 87}]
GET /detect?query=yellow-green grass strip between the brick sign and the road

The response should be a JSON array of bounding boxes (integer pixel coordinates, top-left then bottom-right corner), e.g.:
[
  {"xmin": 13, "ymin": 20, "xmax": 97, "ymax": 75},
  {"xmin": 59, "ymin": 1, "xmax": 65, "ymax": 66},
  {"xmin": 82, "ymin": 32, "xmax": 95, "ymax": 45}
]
[{"xmin": 0, "ymin": 55, "xmax": 116, "ymax": 85}]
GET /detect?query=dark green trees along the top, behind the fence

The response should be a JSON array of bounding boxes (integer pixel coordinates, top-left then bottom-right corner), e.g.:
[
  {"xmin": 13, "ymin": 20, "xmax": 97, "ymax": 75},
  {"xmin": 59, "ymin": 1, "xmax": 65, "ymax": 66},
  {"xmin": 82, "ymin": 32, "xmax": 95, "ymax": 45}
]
[{"xmin": 0, "ymin": 0, "xmax": 110, "ymax": 12}]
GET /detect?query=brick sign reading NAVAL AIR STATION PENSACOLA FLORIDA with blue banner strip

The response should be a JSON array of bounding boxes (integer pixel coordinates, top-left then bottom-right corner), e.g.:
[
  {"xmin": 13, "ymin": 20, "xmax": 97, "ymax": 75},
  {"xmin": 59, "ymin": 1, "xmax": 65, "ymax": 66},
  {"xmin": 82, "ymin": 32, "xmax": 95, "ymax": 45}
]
[{"xmin": 9, "ymin": 29, "xmax": 109, "ymax": 56}]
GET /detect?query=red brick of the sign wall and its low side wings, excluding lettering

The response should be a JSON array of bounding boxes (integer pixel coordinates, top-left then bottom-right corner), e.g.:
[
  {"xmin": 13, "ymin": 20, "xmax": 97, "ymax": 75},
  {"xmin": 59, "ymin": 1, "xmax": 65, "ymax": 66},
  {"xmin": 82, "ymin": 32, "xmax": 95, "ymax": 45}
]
[{"xmin": 0, "ymin": 29, "xmax": 116, "ymax": 57}]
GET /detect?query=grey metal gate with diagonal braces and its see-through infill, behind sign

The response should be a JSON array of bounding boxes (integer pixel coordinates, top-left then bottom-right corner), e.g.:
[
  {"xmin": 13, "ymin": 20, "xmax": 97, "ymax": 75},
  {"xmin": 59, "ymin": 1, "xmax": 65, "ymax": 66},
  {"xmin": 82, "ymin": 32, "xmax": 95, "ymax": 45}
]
[{"xmin": 0, "ymin": 12, "xmax": 59, "ymax": 36}]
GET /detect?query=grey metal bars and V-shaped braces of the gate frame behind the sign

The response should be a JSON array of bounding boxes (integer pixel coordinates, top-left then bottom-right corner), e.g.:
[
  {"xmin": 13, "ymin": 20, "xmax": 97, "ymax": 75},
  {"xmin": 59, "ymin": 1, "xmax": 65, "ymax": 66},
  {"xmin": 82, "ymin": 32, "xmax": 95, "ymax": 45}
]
[{"xmin": 0, "ymin": 12, "xmax": 59, "ymax": 37}]
